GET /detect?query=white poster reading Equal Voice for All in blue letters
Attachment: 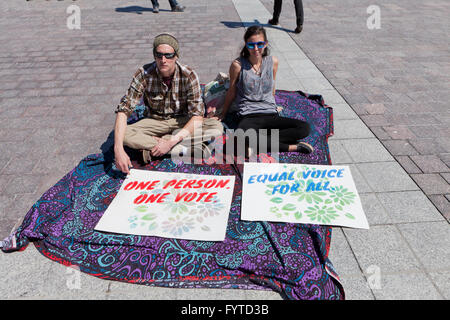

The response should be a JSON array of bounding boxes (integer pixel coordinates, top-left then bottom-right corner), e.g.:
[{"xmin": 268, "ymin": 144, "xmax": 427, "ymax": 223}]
[{"xmin": 241, "ymin": 162, "xmax": 369, "ymax": 229}]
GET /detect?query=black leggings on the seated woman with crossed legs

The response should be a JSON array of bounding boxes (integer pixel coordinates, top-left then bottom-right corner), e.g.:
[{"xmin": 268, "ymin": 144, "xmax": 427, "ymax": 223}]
[{"xmin": 237, "ymin": 114, "xmax": 311, "ymax": 152}]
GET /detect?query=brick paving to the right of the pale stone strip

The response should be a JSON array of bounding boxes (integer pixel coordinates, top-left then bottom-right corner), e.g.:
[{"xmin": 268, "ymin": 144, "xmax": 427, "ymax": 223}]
[{"xmin": 261, "ymin": 0, "xmax": 450, "ymax": 221}]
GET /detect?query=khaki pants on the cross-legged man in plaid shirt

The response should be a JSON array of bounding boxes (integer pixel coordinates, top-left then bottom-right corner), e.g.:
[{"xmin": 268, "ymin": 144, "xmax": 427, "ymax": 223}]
[{"xmin": 123, "ymin": 117, "xmax": 223, "ymax": 155}]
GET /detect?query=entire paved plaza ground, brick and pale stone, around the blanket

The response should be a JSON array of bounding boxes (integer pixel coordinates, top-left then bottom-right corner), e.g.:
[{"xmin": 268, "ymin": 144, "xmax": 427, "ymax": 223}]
[{"xmin": 0, "ymin": 0, "xmax": 450, "ymax": 300}]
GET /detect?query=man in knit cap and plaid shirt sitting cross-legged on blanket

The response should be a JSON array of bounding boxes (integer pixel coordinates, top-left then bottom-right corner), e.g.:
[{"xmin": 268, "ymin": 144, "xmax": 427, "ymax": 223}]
[{"xmin": 114, "ymin": 33, "xmax": 223, "ymax": 173}]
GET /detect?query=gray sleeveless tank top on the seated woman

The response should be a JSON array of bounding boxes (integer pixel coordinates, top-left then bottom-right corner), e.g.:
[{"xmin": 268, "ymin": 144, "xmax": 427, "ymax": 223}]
[{"xmin": 235, "ymin": 56, "xmax": 277, "ymax": 116}]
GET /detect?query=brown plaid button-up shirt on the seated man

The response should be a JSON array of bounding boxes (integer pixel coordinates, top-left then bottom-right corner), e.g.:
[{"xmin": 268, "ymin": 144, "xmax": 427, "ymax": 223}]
[{"xmin": 116, "ymin": 61, "xmax": 205, "ymax": 120}]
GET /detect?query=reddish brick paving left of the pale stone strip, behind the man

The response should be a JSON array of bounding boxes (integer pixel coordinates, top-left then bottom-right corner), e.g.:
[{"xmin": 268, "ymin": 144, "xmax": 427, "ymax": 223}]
[{"xmin": 0, "ymin": 0, "xmax": 246, "ymax": 238}]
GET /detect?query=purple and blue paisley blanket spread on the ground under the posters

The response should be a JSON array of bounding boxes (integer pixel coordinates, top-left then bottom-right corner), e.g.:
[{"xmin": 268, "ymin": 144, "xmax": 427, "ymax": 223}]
[{"xmin": 2, "ymin": 91, "xmax": 344, "ymax": 299}]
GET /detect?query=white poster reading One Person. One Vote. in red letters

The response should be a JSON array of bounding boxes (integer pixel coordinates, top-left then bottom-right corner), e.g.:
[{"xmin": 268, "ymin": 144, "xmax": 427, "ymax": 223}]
[{"xmin": 95, "ymin": 169, "xmax": 234, "ymax": 241}]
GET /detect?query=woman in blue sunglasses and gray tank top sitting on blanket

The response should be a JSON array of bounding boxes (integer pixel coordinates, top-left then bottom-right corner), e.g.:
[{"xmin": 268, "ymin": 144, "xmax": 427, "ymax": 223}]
[{"xmin": 207, "ymin": 26, "xmax": 314, "ymax": 153}]
